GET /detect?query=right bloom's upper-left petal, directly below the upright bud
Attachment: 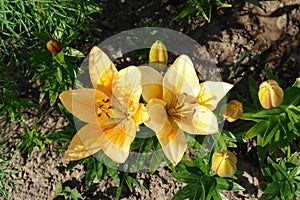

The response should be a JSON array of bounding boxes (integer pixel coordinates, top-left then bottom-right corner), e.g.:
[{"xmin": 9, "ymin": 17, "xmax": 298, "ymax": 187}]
[{"xmin": 138, "ymin": 66, "xmax": 163, "ymax": 102}]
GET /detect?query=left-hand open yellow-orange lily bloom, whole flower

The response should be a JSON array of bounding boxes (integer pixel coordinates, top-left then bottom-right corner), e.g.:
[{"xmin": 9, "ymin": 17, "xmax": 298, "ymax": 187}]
[{"xmin": 60, "ymin": 47, "xmax": 148, "ymax": 163}]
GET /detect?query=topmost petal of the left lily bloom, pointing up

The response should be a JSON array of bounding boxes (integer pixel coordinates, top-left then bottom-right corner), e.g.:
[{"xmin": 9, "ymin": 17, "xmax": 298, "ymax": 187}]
[{"xmin": 89, "ymin": 46, "xmax": 118, "ymax": 97}]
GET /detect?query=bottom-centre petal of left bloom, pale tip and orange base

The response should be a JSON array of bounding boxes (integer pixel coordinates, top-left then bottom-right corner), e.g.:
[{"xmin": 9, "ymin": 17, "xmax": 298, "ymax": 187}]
[{"xmin": 101, "ymin": 118, "xmax": 137, "ymax": 163}]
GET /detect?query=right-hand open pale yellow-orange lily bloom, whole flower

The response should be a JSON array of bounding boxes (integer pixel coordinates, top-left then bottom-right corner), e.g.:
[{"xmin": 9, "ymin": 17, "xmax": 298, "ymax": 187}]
[{"xmin": 139, "ymin": 55, "xmax": 232, "ymax": 165}]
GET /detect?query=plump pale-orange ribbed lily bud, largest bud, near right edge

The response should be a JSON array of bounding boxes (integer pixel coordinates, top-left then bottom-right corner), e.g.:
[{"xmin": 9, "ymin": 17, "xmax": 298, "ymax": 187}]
[{"xmin": 258, "ymin": 80, "xmax": 284, "ymax": 109}]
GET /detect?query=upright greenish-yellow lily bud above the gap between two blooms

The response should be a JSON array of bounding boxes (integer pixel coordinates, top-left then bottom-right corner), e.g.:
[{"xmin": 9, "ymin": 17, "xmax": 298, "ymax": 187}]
[{"xmin": 149, "ymin": 40, "xmax": 168, "ymax": 71}]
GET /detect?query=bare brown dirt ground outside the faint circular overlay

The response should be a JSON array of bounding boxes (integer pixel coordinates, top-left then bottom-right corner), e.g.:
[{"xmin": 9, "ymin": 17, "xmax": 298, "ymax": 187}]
[{"xmin": 0, "ymin": 0, "xmax": 300, "ymax": 200}]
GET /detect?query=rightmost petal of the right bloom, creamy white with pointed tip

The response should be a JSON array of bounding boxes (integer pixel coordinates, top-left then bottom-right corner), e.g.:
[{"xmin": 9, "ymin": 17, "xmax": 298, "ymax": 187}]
[{"xmin": 197, "ymin": 81, "xmax": 233, "ymax": 110}]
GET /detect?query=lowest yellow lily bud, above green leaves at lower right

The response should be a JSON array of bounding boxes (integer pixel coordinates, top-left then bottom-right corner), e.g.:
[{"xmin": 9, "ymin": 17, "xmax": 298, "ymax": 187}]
[{"xmin": 211, "ymin": 151, "xmax": 237, "ymax": 177}]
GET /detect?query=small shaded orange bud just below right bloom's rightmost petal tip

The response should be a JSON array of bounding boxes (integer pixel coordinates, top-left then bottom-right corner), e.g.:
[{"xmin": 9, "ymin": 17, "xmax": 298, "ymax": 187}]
[{"xmin": 221, "ymin": 100, "xmax": 243, "ymax": 122}]
